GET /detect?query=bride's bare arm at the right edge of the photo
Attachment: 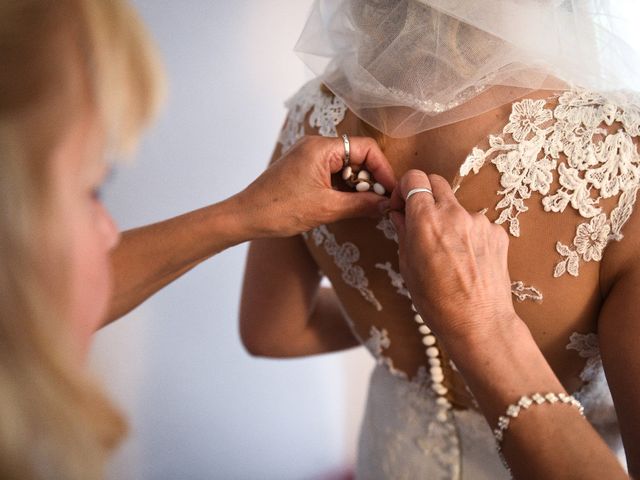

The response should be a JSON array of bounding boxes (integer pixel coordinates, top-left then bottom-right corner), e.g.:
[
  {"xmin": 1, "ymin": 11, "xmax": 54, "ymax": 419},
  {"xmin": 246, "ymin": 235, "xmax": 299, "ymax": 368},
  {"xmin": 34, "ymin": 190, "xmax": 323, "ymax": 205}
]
[{"xmin": 598, "ymin": 195, "xmax": 640, "ymax": 478}]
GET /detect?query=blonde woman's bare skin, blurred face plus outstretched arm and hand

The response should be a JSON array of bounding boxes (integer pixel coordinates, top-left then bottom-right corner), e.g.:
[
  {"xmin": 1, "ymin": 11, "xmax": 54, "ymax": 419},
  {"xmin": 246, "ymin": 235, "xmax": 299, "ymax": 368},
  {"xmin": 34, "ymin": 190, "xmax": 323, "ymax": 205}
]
[{"xmin": 43, "ymin": 43, "xmax": 396, "ymax": 360}]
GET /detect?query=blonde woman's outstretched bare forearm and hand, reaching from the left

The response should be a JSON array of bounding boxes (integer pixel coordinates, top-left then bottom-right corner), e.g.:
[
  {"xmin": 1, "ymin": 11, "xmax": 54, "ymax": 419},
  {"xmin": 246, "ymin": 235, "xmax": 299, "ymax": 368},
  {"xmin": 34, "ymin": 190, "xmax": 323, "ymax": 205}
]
[{"xmin": 102, "ymin": 136, "xmax": 396, "ymax": 325}]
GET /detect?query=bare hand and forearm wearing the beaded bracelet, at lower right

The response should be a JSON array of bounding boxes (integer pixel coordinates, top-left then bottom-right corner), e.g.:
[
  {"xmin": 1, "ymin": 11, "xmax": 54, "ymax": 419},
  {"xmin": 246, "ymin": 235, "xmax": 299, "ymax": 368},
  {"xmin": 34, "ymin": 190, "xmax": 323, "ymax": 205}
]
[{"xmin": 392, "ymin": 170, "xmax": 637, "ymax": 479}]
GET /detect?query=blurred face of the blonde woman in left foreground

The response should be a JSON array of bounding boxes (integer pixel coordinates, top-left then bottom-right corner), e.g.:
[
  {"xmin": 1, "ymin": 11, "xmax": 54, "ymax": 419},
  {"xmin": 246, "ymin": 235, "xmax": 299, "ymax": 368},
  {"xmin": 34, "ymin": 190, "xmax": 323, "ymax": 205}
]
[{"xmin": 52, "ymin": 104, "xmax": 119, "ymax": 358}]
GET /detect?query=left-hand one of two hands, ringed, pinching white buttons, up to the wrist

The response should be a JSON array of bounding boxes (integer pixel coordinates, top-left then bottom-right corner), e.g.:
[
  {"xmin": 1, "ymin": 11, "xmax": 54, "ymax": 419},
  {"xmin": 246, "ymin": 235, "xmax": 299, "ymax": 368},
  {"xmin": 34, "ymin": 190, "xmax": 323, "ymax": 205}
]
[{"xmin": 238, "ymin": 136, "xmax": 396, "ymax": 237}]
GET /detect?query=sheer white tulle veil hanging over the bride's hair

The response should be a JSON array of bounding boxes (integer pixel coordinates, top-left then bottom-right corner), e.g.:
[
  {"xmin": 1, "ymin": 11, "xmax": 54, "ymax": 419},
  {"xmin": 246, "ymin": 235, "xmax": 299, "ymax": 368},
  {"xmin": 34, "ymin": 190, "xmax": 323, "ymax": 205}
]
[{"xmin": 296, "ymin": 0, "xmax": 640, "ymax": 137}]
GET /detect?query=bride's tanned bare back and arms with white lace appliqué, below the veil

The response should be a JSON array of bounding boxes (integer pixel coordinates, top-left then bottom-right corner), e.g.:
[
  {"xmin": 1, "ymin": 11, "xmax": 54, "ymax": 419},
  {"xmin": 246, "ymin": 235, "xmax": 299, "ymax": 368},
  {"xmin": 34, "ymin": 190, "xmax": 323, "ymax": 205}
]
[{"xmin": 241, "ymin": 82, "xmax": 640, "ymax": 472}]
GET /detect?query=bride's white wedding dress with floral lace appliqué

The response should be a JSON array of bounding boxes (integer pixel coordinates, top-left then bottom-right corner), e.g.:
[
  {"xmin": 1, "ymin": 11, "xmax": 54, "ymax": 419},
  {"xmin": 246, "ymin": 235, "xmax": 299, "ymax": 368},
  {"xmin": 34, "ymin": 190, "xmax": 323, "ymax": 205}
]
[{"xmin": 280, "ymin": 80, "xmax": 640, "ymax": 480}]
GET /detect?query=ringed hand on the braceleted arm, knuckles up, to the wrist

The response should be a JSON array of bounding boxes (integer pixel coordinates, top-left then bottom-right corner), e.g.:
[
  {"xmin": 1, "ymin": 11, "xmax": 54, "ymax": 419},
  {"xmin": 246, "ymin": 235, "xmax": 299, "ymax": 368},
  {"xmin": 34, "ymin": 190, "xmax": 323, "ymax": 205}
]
[{"xmin": 391, "ymin": 170, "xmax": 521, "ymax": 344}]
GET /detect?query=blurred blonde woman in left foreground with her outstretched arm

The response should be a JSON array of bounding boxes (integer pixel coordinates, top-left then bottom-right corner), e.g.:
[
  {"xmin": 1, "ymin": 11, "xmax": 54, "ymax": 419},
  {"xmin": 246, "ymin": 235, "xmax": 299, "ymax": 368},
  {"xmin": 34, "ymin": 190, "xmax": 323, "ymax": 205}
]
[{"xmin": 0, "ymin": 0, "xmax": 395, "ymax": 480}]
